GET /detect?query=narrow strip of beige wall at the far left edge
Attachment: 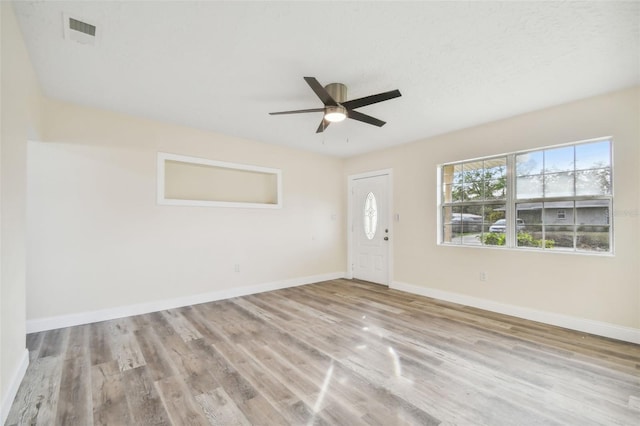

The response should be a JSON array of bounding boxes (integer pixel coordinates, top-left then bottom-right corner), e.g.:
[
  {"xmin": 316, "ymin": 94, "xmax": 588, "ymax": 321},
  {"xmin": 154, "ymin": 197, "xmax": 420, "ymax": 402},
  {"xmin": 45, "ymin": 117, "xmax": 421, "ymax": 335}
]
[{"xmin": 0, "ymin": 2, "xmax": 40, "ymax": 420}]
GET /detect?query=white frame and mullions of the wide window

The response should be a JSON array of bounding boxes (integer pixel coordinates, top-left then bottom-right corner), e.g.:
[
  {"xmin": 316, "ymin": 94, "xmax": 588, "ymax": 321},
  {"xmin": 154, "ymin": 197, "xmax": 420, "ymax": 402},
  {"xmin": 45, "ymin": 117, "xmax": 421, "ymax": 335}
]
[{"xmin": 436, "ymin": 136, "xmax": 614, "ymax": 256}]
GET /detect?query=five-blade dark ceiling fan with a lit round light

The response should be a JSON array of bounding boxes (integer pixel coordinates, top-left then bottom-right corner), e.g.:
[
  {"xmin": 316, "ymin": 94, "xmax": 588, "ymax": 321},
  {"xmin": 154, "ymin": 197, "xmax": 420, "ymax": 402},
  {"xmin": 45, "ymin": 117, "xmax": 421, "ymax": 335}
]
[{"xmin": 269, "ymin": 77, "xmax": 402, "ymax": 133}]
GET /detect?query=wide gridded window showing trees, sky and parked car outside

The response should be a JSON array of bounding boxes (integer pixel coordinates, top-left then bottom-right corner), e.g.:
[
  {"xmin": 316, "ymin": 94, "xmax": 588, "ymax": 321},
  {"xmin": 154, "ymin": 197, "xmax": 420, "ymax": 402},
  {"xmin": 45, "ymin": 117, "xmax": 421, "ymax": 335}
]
[{"xmin": 439, "ymin": 139, "xmax": 613, "ymax": 253}]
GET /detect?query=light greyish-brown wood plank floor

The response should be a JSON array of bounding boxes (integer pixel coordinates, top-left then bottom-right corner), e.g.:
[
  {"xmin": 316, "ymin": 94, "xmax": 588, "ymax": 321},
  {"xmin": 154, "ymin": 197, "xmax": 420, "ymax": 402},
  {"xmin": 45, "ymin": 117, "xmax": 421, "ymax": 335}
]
[{"xmin": 6, "ymin": 280, "xmax": 640, "ymax": 426}]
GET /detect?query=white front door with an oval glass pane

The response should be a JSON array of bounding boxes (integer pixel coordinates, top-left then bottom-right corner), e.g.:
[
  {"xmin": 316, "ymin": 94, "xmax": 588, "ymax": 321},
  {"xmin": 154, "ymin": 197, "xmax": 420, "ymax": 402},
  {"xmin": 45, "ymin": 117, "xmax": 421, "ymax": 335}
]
[{"xmin": 351, "ymin": 174, "xmax": 391, "ymax": 285}]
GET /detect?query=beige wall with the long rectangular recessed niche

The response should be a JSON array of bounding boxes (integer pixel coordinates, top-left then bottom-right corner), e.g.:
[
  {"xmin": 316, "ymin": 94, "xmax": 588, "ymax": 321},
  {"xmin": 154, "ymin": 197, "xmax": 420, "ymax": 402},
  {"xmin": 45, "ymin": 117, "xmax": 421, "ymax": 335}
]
[{"xmin": 27, "ymin": 100, "xmax": 346, "ymax": 319}]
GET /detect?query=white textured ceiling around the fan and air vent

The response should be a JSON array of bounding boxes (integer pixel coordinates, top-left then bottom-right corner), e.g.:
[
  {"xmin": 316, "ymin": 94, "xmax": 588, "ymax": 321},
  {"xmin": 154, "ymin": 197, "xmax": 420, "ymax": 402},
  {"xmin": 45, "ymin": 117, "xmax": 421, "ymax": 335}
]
[{"xmin": 14, "ymin": 1, "xmax": 640, "ymax": 157}]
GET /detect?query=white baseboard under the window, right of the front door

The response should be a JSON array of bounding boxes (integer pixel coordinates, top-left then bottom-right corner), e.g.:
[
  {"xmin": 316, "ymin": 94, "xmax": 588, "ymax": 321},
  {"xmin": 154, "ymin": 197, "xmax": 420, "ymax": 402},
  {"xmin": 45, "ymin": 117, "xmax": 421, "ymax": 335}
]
[{"xmin": 390, "ymin": 281, "xmax": 640, "ymax": 344}]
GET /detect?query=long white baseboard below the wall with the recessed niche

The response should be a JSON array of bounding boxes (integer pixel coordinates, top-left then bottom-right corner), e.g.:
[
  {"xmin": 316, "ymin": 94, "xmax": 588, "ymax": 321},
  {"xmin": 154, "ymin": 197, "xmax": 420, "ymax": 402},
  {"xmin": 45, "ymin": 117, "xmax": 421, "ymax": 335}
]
[{"xmin": 27, "ymin": 272, "xmax": 345, "ymax": 333}]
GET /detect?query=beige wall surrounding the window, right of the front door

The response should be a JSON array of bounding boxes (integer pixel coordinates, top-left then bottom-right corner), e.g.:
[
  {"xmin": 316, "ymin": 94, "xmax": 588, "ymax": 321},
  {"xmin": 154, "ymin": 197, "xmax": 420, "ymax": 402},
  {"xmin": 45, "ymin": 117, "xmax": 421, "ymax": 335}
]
[{"xmin": 345, "ymin": 87, "xmax": 640, "ymax": 328}]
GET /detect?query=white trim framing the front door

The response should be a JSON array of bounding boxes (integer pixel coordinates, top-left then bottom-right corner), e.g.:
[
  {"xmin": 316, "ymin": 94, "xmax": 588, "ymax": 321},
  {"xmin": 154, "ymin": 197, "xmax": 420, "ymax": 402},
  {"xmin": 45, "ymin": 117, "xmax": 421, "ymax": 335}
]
[{"xmin": 346, "ymin": 169, "xmax": 395, "ymax": 287}]
